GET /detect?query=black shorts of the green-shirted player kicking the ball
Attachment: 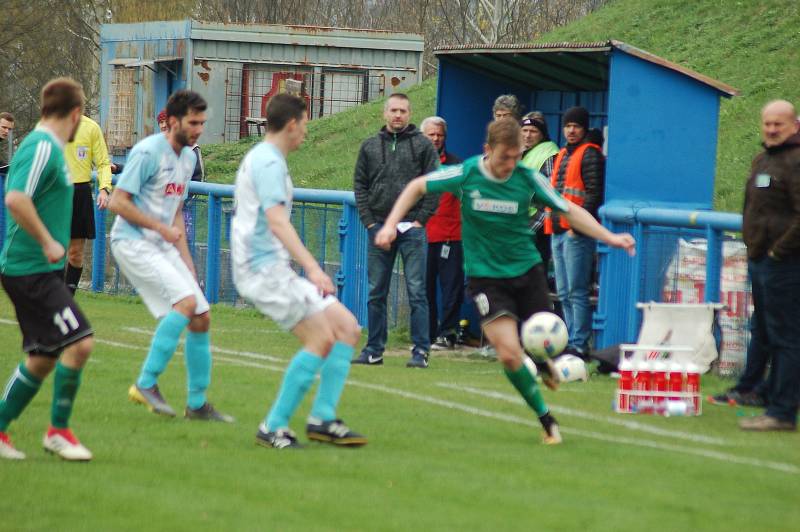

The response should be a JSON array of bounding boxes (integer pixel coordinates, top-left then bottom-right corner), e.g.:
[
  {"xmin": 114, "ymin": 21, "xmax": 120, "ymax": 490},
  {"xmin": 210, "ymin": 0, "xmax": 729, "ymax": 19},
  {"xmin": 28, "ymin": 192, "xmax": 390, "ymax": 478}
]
[{"xmin": 467, "ymin": 264, "xmax": 553, "ymax": 325}]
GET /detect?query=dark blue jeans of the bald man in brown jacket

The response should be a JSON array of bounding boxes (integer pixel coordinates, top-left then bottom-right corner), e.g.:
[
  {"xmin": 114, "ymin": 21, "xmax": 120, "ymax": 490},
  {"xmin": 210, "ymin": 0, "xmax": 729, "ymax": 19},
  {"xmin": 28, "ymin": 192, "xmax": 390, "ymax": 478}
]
[{"xmin": 747, "ymin": 256, "xmax": 800, "ymax": 423}]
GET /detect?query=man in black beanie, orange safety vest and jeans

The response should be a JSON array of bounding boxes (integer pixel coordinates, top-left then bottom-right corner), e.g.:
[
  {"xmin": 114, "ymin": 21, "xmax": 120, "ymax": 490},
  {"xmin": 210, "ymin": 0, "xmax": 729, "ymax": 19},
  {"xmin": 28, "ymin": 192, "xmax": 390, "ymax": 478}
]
[{"xmin": 545, "ymin": 107, "xmax": 605, "ymax": 358}]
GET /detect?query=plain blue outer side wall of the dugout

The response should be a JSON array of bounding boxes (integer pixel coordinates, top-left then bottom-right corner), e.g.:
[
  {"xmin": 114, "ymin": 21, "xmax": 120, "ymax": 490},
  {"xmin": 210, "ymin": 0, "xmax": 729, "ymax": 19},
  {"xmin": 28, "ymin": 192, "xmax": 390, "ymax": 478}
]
[{"xmin": 606, "ymin": 50, "xmax": 719, "ymax": 209}]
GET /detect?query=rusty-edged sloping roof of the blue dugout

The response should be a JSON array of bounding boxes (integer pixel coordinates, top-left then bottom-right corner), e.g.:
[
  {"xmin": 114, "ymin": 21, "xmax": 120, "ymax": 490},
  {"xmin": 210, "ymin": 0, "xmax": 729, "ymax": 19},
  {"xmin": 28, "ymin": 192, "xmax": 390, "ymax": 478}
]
[{"xmin": 434, "ymin": 40, "xmax": 739, "ymax": 97}]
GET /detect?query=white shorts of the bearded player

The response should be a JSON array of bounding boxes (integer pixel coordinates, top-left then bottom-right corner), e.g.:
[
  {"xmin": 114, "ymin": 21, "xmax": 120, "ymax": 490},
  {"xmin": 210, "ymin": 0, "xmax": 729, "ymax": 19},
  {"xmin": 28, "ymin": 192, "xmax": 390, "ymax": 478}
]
[{"xmin": 111, "ymin": 240, "xmax": 209, "ymax": 319}]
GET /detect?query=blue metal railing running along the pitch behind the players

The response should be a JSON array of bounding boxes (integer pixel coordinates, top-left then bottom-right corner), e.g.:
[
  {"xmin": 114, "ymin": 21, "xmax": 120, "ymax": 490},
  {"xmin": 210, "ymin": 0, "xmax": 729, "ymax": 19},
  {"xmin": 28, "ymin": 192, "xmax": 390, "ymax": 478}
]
[{"xmin": 0, "ymin": 170, "xmax": 742, "ymax": 366}]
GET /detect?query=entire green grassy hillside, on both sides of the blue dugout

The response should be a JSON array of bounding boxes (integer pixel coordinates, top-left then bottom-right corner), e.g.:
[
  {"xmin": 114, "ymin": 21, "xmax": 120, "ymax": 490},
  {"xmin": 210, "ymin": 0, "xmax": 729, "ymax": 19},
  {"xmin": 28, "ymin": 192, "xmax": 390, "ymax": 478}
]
[{"xmin": 202, "ymin": 0, "xmax": 800, "ymax": 211}]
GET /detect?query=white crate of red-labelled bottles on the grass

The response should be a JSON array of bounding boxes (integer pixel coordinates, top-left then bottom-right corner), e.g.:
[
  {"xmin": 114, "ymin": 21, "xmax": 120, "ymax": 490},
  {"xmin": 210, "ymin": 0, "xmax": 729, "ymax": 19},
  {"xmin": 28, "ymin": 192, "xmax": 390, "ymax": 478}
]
[{"xmin": 614, "ymin": 360, "xmax": 702, "ymax": 416}]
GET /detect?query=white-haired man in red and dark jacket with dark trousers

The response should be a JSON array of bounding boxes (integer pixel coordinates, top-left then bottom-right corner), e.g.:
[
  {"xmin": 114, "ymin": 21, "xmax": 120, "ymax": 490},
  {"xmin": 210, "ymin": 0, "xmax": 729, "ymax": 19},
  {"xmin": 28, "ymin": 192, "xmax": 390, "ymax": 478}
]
[{"xmin": 420, "ymin": 116, "xmax": 464, "ymax": 350}]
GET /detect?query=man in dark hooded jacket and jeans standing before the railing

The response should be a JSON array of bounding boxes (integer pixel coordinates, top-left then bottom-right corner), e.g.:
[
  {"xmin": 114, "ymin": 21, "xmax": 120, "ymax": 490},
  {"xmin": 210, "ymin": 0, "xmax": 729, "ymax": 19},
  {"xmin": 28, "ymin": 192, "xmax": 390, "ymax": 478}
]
[{"xmin": 353, "ymin": 93, "xmax": 439, "ymax": 368}]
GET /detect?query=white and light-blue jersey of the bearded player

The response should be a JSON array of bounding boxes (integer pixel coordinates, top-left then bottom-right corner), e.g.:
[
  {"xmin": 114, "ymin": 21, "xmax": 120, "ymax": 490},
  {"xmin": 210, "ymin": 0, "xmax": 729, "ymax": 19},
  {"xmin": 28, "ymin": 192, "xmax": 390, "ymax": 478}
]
[{"xmin": 111, "ymin": 133, "xmax": 197, "ymax": 244}]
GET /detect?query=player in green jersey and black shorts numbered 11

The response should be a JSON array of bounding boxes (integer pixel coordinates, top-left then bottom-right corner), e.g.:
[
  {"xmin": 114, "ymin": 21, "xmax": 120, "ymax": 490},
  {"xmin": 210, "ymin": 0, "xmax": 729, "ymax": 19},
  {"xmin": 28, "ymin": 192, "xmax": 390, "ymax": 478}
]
[{"xmin": 0, "ymin": 78, "xmax": 93, "ymax": 461}]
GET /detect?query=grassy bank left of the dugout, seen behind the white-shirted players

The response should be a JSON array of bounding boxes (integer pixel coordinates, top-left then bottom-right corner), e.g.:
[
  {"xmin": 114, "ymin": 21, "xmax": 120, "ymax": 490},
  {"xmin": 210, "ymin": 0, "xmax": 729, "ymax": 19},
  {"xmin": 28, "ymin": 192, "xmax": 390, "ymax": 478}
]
[{"xmin": 204, "ymin": 79, "xmax": 436, "ymax": 190}]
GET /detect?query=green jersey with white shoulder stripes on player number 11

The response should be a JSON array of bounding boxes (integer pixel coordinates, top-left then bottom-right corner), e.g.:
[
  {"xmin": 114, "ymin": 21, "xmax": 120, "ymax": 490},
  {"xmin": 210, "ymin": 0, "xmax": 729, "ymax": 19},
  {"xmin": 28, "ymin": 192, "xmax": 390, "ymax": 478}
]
[{"xmin": 0, "ymin": 126, "xmax": 73, "ymax": 275}]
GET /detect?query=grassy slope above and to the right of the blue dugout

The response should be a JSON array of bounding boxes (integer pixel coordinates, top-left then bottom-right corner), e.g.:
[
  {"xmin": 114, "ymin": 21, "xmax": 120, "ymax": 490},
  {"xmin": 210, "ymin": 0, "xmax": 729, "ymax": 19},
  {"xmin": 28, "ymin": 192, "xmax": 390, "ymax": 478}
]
[{"xmin": 542, "ymin": 0, "xmax": 800, "ymax": 212}]
